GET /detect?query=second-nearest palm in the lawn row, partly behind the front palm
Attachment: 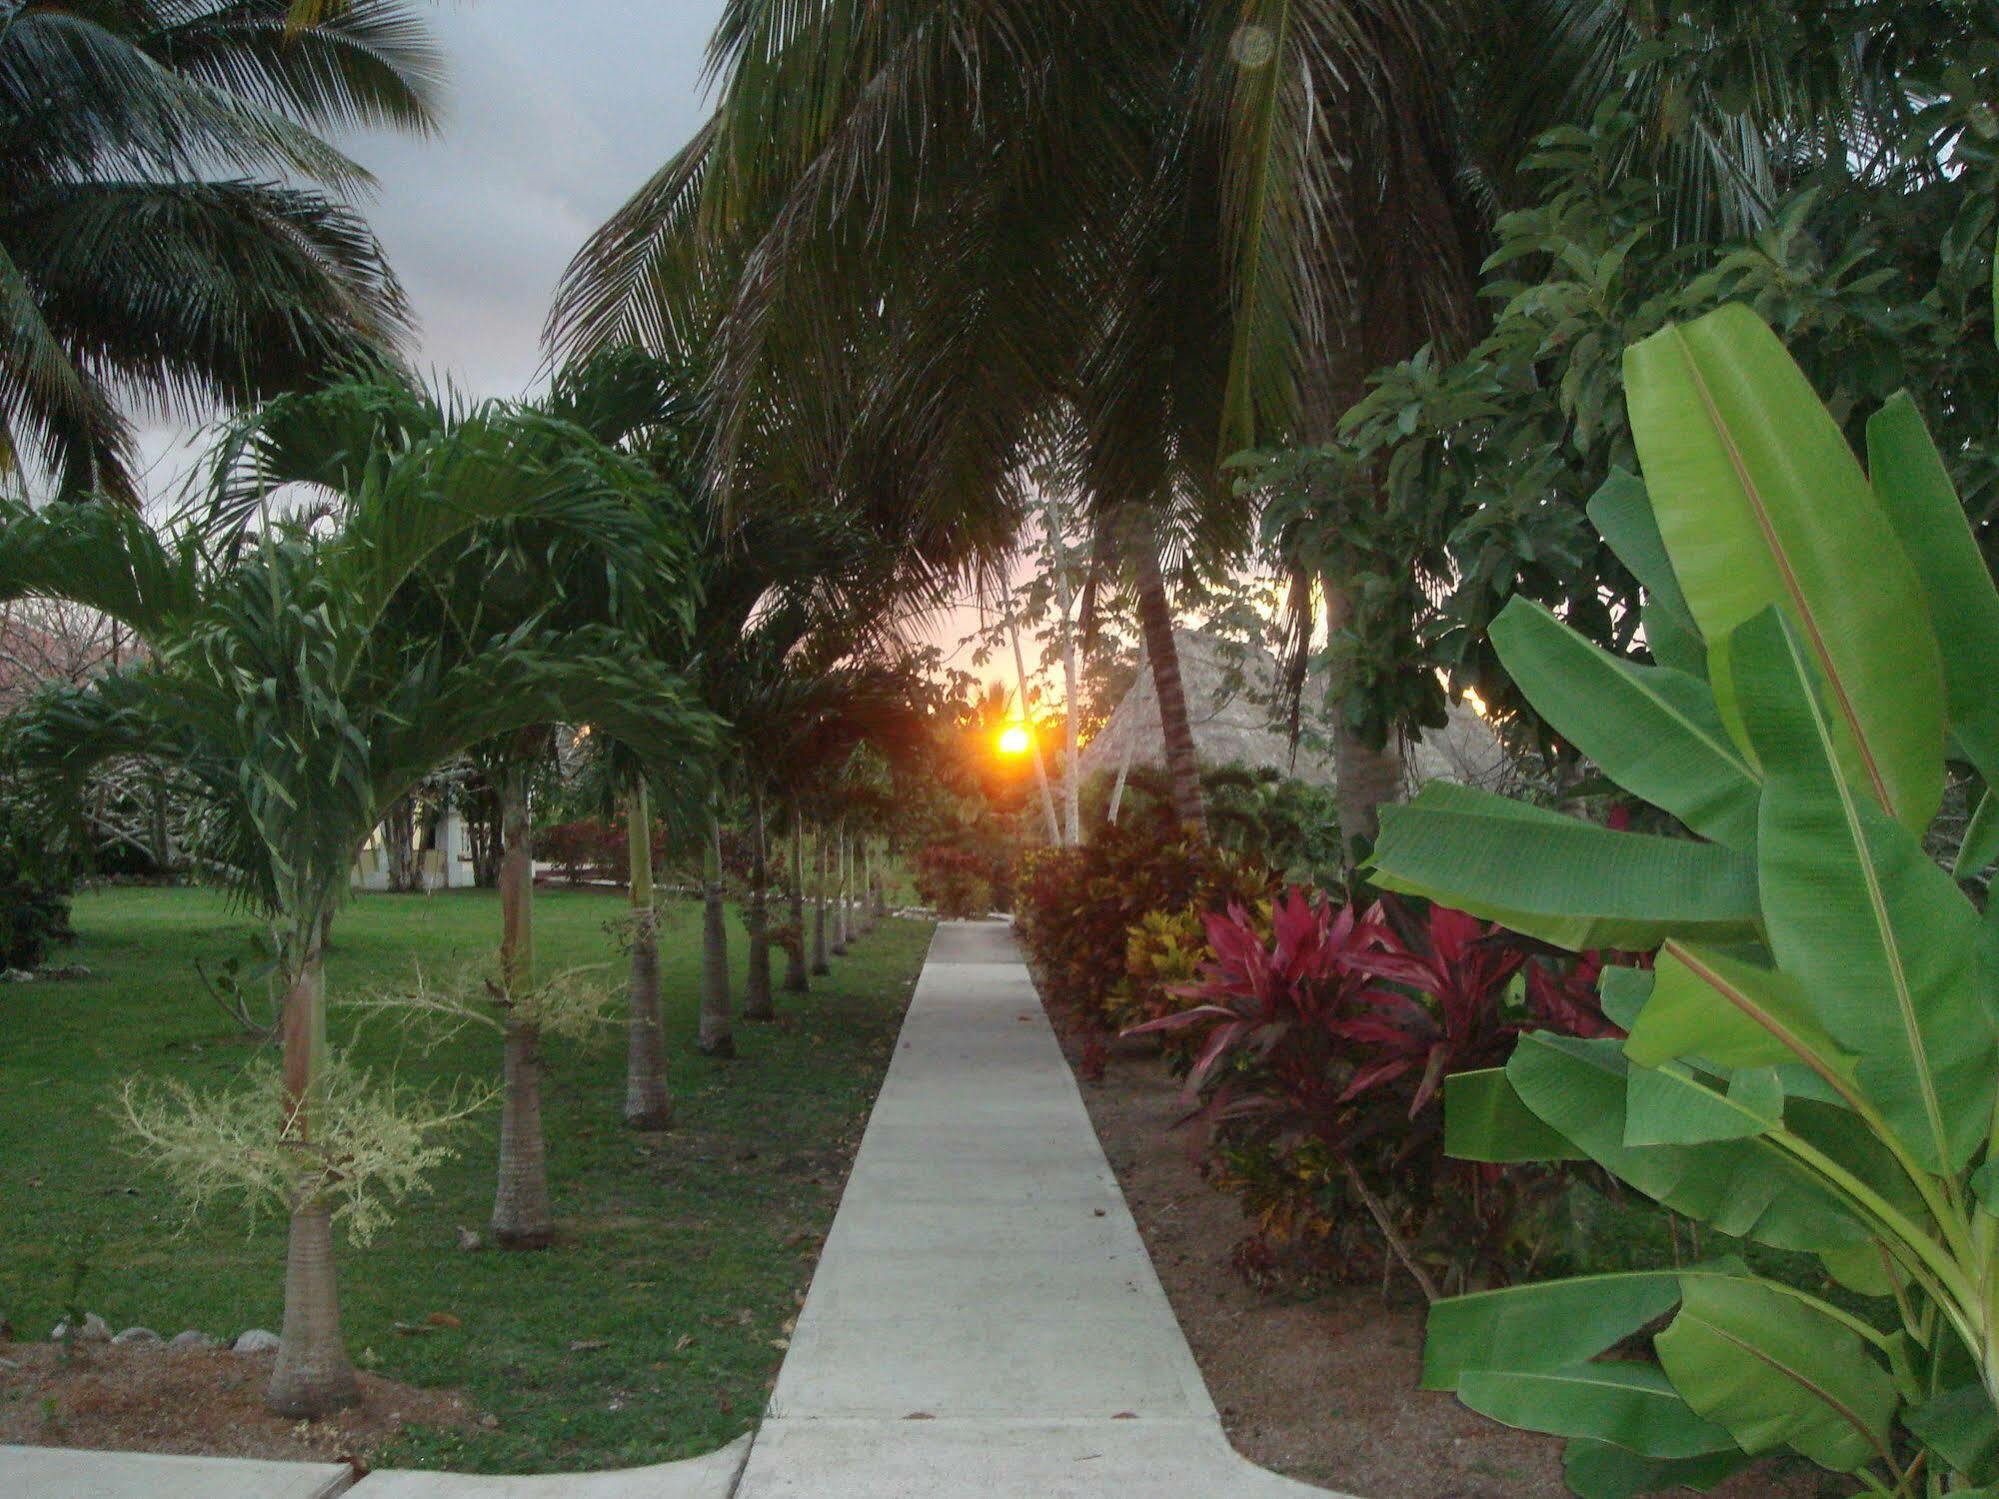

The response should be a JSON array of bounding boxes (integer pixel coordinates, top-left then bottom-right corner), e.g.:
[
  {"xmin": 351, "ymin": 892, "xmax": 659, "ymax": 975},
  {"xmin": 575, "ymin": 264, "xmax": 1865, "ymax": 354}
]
[{"xmin": 194, "ymin": 354, "xmax": 719, "ymax": 1249}]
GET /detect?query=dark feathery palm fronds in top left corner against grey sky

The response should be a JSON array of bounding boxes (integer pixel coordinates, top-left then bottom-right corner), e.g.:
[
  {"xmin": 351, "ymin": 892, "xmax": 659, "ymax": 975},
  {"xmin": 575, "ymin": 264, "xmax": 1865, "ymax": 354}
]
[{"xmin": 0, "ymin": 0, "xmax": 440, "ymax": 504}]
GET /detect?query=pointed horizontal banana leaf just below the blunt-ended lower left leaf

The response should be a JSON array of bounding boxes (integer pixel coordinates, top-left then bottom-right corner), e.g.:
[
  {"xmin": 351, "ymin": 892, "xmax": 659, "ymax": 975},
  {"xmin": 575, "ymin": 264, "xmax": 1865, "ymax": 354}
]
[{"xmin": 1457, "ymin": 1363, "xmax": 1735, "ymax": 1457}]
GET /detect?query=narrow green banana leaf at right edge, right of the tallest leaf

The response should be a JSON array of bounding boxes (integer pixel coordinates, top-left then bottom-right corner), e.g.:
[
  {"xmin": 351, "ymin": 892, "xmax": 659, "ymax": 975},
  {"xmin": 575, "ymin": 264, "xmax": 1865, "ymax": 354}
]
[{"xmin": 1867, "ymin": 394, "xmax": 1999, "ymax": 785}]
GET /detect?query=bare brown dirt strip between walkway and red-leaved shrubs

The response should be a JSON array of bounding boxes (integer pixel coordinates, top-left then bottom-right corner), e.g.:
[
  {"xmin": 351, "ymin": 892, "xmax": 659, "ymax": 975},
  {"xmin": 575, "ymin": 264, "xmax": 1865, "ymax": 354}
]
[{"xmin": 1057, "ymin": 1017, "xmax": 1851, "ymax": 1499}]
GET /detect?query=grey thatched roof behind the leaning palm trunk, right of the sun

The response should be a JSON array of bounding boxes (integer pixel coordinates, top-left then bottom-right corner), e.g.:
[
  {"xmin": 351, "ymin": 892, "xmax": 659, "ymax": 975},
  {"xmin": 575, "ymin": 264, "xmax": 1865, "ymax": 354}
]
[{"xmin": 1081, "ymin": 630, "xmax": 1505, "ymax": 787}]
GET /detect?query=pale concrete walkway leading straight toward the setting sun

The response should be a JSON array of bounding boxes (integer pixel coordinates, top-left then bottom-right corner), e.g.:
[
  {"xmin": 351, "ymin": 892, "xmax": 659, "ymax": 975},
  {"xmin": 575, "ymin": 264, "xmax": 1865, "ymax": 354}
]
[{"xmin": 0, "ymin": 921, "xmax": 1327, "ymax": 1499}]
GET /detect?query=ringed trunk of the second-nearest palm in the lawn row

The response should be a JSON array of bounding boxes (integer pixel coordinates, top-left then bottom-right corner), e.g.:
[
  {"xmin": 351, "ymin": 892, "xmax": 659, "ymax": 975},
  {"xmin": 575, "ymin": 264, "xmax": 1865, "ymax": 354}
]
[{"xmin": 494, "ymin": 763, "xmax": 556, "ymax": 1249}]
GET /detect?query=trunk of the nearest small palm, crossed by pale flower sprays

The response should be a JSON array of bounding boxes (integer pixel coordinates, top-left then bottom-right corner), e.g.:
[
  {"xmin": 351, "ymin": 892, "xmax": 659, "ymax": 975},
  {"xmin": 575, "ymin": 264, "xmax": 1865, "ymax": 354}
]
[{"xmin": 266, "ymin": 943, "xmax": 362, "ymax": 1419}]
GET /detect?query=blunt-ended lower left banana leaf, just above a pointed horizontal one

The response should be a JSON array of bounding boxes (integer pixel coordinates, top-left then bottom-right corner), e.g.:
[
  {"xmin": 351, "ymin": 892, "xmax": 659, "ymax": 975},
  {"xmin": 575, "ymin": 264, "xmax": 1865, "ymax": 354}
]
[{"xmin": 1423, "ymin": 1271, "xmax": 1679, "ymax": 1389}]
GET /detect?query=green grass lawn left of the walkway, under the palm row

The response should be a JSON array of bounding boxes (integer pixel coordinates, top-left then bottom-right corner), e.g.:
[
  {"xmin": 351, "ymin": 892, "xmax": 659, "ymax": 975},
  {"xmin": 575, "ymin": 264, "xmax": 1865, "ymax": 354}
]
[{"xmin": 0, "ymin": 889, "xmax": 930, "ymax": 1471}]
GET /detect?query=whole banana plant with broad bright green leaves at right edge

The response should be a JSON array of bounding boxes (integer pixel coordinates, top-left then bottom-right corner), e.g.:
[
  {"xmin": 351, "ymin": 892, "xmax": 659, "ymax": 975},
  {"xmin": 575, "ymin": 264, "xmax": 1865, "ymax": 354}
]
[{"xmin": 1375, "ymin": 308, "xmax": 1999, "ymax": 1499}]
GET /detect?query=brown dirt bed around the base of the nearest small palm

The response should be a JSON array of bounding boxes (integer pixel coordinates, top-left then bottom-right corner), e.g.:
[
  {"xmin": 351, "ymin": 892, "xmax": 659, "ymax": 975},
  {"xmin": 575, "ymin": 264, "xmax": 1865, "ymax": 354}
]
[{"xmin": 0, "ymin": 1343, "xmax": 474, "ymax": 1467}]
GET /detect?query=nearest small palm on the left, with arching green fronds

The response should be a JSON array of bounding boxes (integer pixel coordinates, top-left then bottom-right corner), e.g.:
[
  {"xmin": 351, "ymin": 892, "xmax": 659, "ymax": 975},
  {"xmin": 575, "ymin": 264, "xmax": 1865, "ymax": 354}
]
[{"xmin": 0, "ymin": 443, "xmax": 706, "ymax": 1417}]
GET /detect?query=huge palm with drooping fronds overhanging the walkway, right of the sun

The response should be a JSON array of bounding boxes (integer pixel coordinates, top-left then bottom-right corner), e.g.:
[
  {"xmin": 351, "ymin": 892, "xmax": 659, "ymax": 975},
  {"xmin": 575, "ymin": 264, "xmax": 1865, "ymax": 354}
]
[{"xmin": 552, "ymin": 0, "xmax": 1963, "ymax": 847}]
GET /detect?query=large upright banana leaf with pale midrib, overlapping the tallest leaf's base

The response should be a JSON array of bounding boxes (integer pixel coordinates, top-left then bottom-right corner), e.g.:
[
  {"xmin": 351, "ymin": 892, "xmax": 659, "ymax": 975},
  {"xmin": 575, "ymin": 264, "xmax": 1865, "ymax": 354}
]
[{"xmin": 1729, "ymin": 614, "xmax": 1999, "ymax": 1173}]
